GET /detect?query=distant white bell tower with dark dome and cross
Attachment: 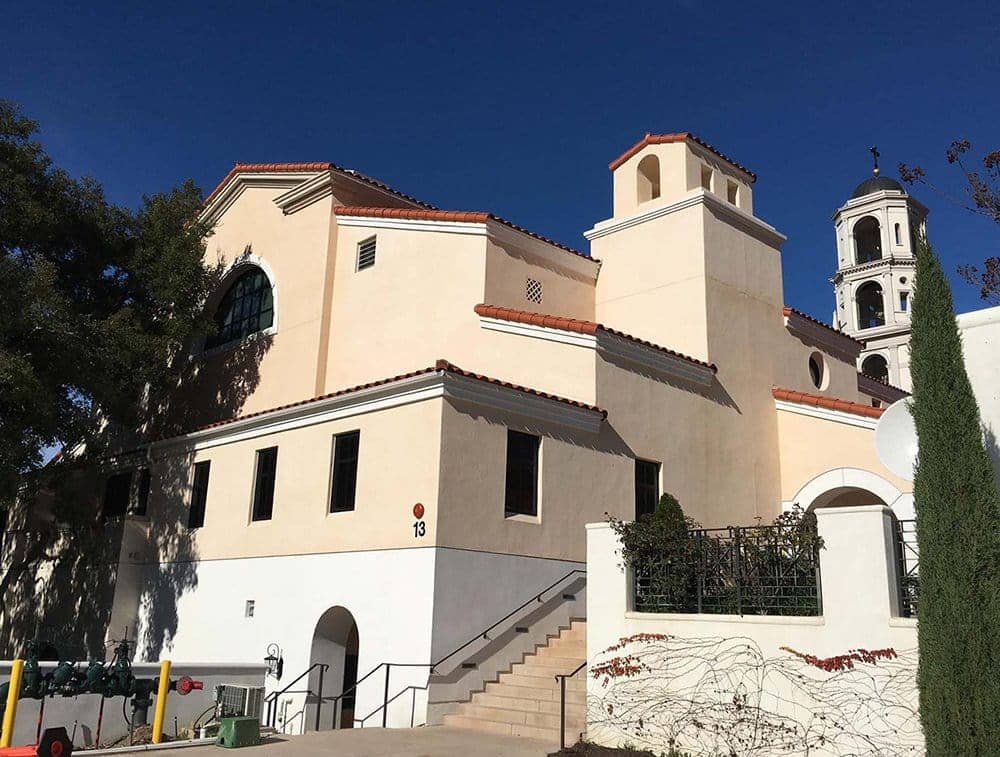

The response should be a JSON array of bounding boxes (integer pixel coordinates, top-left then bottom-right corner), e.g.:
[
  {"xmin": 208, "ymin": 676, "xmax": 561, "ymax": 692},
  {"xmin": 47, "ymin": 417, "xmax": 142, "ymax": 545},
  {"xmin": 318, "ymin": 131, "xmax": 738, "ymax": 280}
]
[{"xmin": 831, "ymin": 147, "xmax": 927, "ymax": 391}]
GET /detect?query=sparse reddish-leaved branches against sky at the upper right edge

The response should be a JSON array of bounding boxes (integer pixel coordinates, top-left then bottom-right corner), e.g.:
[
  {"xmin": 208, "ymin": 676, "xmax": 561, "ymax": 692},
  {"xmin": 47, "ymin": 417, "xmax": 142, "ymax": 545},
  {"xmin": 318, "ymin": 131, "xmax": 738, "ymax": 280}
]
[{"xmin": 899, "ymin": 139, "xmax": 1000, "ymax": 305}]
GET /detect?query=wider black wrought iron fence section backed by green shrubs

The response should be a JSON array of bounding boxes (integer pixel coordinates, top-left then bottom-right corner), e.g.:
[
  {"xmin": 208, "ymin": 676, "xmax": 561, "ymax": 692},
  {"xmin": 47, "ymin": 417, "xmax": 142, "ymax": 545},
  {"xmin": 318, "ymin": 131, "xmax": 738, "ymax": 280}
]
[{"xmin": 632, "ymin": 525, "xmax": 822, "ymax": 615}]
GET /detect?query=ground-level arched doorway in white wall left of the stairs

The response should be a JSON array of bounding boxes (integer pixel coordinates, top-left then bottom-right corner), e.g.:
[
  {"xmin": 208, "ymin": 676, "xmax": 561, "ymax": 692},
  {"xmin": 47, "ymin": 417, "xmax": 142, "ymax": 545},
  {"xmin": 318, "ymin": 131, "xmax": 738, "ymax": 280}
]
[{"xmin": 306, "ymin": 606, "xmax": 358, "ymax": 729}]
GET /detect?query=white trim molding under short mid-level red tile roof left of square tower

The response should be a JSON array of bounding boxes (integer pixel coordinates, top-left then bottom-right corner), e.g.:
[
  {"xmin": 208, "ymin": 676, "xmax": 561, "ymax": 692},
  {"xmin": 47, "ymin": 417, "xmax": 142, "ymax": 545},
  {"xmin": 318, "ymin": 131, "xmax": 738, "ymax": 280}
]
[{"xmin": 479, "ymin": 316, "xmax": 715, "ymax": 386}]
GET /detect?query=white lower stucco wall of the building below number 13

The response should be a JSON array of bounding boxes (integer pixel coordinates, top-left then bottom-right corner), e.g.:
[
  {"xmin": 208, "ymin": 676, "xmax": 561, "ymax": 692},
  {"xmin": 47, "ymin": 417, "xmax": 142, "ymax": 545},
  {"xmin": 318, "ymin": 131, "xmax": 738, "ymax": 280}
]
[{"xmin": 117, "ymin": 547, "xmax": 585, "ymax": 733}]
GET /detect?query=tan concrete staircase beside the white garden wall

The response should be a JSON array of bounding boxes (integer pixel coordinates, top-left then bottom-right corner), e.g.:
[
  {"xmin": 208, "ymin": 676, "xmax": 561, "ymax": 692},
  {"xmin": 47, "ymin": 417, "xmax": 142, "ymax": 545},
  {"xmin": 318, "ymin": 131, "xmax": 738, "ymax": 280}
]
[{"xmin": 444, "ymin": 620, "xmax": 587, "ymax": 744}]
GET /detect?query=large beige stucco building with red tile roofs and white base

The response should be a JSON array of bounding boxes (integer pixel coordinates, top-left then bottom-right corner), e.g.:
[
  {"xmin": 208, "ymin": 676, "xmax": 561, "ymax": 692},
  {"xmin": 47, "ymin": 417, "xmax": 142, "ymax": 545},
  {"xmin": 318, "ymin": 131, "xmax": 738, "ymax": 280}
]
[{"xmin": 3, "ymin": 134, "xmax": 911, "ymax": 736}]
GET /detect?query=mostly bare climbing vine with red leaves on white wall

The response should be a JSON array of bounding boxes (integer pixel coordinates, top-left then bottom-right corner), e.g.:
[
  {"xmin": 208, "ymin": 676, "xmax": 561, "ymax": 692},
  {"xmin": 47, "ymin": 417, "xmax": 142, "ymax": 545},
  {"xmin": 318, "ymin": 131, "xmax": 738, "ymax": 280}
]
[{"xmin": 588, "ymin": 634, "xmax": 923, "ymax": 757}]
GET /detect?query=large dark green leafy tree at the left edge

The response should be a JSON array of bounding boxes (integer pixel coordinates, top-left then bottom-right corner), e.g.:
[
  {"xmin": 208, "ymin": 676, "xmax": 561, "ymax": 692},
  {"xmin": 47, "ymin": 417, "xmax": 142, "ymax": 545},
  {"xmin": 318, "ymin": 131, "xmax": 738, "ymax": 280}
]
[{"xmin": 0, "ymin": 100, "xmax": 218, "ymax": 516}]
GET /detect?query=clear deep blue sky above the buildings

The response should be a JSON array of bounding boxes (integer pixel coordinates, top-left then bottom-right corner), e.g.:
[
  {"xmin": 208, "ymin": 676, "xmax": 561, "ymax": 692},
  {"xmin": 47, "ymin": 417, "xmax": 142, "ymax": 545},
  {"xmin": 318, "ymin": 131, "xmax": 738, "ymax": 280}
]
[{"xmin": 0, "ymin": 0, "xmax": 1000, "ymax": 321}]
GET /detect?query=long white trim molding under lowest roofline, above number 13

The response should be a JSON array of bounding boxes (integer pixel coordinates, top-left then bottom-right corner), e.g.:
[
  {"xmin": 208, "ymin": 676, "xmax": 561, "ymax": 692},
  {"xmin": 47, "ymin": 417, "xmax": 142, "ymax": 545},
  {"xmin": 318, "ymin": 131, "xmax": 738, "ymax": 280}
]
[{"xmin": 150, "ymin": 370, "xmax": 604, "ymax": 453}]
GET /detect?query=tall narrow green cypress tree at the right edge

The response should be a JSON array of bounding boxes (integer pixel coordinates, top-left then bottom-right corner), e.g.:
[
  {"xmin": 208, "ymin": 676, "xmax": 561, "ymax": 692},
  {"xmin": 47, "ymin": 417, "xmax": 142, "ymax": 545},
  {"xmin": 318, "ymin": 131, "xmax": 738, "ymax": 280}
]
[{"xmin": 910, "ymin": 235, "xmax": 1000, "ymax": 756}]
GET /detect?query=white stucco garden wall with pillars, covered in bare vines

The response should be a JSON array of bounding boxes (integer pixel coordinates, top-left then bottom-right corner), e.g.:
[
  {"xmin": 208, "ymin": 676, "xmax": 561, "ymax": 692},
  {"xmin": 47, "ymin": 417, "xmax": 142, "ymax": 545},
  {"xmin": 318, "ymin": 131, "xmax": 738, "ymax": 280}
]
[{"xmin": 587, "ymin": 505, "xmax": 923, "ymax": 755}]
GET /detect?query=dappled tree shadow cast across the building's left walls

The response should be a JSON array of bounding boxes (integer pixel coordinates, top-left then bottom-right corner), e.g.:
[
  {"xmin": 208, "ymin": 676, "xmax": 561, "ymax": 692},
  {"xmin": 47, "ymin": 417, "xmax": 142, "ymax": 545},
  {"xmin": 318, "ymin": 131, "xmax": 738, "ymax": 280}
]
[{"xmin": 0, "ymin": 335, "xmax": 272, "ymax": 660}]
